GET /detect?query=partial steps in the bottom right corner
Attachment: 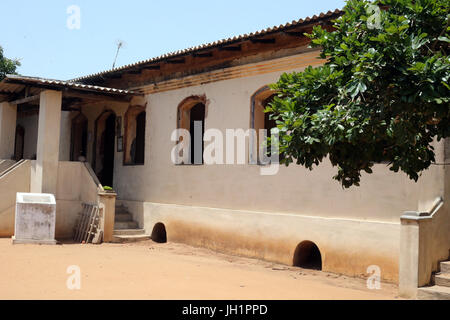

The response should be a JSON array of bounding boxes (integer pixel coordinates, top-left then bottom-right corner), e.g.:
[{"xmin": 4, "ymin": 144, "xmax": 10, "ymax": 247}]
[{"xmin": 417, "ymin": 261, "xmax": 450, "ymax": 300}]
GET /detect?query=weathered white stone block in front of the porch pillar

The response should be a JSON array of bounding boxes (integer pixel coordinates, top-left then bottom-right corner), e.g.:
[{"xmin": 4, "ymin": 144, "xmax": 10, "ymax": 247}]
[{"xmin": 13, "ymin": 193, "xmax": 56, "ymax": 244}]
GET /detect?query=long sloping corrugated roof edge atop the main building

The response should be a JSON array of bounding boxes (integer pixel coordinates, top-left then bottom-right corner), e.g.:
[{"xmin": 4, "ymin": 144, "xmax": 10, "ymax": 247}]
[{"xmin": 73, "ymin": 9, "xmax": 343, "ymax": 82}]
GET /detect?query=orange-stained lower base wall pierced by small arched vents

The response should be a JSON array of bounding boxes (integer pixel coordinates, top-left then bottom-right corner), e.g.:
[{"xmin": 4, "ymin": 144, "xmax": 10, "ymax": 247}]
[{"xmin": 120, "ymin": 201, "xmax": 400, "ymax": 283}]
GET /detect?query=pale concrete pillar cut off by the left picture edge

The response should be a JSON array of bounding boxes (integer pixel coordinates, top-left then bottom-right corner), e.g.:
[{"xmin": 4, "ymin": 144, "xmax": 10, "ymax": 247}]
[{"xmin": 0, "ymin": 102, "xmax": 17, "ymax": 160}]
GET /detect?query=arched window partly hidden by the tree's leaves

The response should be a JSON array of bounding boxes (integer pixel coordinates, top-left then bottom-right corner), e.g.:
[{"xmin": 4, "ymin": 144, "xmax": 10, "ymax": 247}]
[{"xmin": 250, "ymin": 86, "xmax": 277, "ymax": 164}]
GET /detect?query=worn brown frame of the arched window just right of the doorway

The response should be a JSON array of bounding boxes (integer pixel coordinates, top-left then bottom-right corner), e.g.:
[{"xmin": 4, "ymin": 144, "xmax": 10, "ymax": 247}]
[{"xmin": 123, "ymin": 105, "xmax": 147, "ymax": 166}]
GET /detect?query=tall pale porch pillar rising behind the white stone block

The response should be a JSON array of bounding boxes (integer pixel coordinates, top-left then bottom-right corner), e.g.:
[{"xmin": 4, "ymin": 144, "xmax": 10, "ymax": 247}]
[{"xmin": 34, "ymin": 90, "xmax": 62, "ymax": 194}]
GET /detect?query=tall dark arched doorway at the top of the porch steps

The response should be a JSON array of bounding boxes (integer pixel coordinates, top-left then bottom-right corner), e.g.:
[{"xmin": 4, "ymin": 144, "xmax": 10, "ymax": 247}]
[{"xmin": 94, "ymin": 110, "xmax": 116, "ymax": 187}]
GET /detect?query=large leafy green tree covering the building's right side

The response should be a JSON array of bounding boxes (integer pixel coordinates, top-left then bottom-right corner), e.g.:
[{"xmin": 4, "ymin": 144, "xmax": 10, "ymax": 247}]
[{"xmin": 266, "ymin": 0, "xmax": 450, "ymax": 188}]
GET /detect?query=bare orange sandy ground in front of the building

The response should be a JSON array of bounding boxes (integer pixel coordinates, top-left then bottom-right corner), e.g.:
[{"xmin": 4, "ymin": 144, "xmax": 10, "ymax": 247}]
[{"xmin": 0, "ymin": 239, "xmax": 397, "ymax": 300}]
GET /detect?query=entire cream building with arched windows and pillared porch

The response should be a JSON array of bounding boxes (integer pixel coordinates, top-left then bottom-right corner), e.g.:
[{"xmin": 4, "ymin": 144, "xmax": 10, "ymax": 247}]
[{"xmin": 0, "ymin": 11, "xmax": 450, "ymax": 295}]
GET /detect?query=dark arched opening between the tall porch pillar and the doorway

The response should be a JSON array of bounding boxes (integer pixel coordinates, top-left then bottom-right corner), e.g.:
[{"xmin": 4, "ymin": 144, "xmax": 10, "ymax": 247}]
[{"xmin": 70, "ymin": 112, "xmax": 88, "ymax": 161}]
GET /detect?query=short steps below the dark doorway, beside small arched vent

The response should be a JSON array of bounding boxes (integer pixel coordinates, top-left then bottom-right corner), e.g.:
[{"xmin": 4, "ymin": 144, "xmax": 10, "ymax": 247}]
[{"xmin": 113, "ymin": 205, "xmax": 150, "ymax": 243}]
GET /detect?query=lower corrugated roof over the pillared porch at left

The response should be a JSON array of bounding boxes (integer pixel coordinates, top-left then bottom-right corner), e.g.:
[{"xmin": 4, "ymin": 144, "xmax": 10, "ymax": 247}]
[{"xmin": 0, "ymin": 75, "xmax": 139, "ymax": 96}]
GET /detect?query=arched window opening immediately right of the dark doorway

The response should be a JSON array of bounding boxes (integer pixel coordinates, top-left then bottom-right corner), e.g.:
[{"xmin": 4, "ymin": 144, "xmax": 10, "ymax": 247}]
[{"xmin": 123, "ymin": 106, "xmax": 147, "ymax": 165}]
